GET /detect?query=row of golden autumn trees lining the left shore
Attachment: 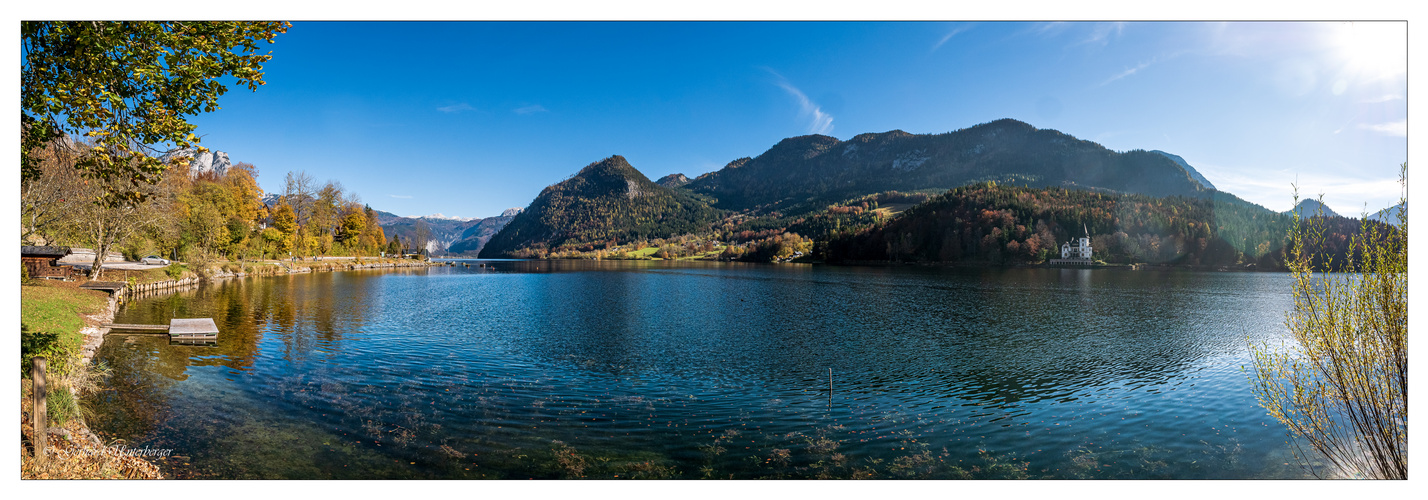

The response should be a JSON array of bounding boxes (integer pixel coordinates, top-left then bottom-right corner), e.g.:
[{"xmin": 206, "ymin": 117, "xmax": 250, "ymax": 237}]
[{"xmin": 20, "ymin": 137, "xmax": 398, "ymax": 277}]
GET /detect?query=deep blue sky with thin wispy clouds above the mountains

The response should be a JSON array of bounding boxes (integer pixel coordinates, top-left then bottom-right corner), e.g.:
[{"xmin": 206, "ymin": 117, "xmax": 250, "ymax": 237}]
[{"xmin": 178, "ymin": 21, "xmax": 1408, "ymax": 217}]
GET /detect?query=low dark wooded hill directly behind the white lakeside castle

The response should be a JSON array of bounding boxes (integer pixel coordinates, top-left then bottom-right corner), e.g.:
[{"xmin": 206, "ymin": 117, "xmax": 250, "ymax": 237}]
[{"xmin": 825, "ymin": 183, "xmax": 1292, "ymax": 266}]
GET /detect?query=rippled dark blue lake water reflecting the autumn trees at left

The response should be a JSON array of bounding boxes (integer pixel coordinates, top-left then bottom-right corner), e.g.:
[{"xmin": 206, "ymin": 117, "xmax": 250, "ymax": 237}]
[{"xmin": 91, "ymin": 260, "xmax": 1302, "ymax": 479}]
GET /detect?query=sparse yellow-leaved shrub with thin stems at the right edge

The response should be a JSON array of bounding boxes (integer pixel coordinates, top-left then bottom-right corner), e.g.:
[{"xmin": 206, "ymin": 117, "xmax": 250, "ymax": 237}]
[{"xmin": 1251, "ymin": 163, "xmax": 1408, "ymax": 479}]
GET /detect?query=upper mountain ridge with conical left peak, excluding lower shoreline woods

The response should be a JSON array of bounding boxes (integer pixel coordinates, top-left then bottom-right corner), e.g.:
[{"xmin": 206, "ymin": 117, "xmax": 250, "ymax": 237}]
[{"xmin": 480, "ymin": 119, "xmax": 1214, "ymax": 257}]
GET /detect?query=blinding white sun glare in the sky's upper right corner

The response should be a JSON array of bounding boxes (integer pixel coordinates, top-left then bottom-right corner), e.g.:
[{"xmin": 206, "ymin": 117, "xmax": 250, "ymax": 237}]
[{"xmin": 1332, "ymin": 23, "xmax": 1408, "ymax": 81}]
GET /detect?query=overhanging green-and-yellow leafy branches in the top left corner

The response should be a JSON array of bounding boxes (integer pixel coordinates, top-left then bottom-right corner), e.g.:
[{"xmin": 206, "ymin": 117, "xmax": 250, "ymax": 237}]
[{"xmin": 20, "ymin": 21, "xmax": 290, "ymax": 206}]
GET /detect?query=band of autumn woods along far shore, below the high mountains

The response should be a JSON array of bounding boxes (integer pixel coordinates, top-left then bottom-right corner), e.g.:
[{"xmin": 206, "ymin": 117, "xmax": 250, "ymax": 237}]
[{"xmin": 494, "ymin": 176, "xmax": 1394, "ymax": 270}]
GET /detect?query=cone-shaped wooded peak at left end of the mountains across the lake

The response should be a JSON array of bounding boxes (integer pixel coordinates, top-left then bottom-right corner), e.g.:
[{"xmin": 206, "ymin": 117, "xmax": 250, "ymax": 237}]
[{"xmin": 480, "ymin": 156, "xmax": 720, "ymax": 257}]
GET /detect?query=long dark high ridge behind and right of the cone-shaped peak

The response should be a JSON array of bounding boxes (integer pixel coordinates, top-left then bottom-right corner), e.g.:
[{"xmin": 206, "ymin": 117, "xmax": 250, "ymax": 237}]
[{"xmin": 685, "ymin": 119, "xmax": 1210, "ymax": 211}]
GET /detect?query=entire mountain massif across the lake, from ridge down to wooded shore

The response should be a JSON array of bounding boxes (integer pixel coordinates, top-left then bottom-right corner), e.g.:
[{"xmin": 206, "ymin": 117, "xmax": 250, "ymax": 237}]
[{"xmin": 463, "ymin": 120, "xmax": 1357, "ymax": 269}]
